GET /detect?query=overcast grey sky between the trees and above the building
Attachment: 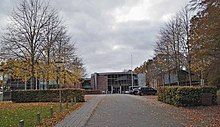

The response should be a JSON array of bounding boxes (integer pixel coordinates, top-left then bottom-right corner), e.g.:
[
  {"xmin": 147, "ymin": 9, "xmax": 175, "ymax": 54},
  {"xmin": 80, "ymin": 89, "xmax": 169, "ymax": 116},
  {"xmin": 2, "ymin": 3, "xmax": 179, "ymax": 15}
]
[{"xmin": 0, "ymin": 0, "xmax": 189, "ymax": 75}]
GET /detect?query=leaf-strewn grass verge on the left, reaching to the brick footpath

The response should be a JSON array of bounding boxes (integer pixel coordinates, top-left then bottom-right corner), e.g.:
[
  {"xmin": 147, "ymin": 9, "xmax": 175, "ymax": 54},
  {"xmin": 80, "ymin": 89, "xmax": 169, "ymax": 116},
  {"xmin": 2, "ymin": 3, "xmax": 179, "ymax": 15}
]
[{"xmin": 0, "ymin": 102, "xmax": 83, "ymax": 127}]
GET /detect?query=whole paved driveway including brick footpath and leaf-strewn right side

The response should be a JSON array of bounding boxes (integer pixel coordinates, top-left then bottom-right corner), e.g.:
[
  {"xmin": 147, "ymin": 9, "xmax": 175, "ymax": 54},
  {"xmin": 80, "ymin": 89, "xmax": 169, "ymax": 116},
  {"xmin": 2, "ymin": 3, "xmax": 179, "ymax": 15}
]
[{"xmin": 56, "ymin": 94, "xmax": 220, "ymax": 127}]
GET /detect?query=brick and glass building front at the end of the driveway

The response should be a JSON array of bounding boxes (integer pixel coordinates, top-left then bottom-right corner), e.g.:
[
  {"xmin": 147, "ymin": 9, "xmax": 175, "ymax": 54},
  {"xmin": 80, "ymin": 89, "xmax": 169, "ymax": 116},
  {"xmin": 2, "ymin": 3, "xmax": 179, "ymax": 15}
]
[{"xmin": 91, "ymin": 71, "xmax": 138, "ymax": 93}]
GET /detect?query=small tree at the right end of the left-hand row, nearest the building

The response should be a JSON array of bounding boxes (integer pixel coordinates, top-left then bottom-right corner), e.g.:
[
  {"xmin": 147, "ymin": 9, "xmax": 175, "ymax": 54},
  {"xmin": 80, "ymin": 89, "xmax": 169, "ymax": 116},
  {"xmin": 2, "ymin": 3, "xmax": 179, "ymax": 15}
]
[{"xmin": 53, "ymin": 28, "xmax": 84, "ymax": 86}]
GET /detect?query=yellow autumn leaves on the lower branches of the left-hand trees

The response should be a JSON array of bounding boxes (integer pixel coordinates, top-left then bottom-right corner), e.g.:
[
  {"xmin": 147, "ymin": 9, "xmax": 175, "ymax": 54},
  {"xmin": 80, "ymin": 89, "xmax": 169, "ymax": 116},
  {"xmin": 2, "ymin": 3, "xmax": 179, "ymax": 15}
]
[{"xmin": 1, "ymin": 59, "xmax": 83, "ymax": 87}]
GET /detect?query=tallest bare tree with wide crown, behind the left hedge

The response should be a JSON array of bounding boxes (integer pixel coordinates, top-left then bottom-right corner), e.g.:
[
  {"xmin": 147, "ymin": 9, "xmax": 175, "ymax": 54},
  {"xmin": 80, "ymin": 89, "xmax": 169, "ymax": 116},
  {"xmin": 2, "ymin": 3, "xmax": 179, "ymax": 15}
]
[{"xmin": 2, "ymin": 0, "xmax": 61, "ymax": 88}]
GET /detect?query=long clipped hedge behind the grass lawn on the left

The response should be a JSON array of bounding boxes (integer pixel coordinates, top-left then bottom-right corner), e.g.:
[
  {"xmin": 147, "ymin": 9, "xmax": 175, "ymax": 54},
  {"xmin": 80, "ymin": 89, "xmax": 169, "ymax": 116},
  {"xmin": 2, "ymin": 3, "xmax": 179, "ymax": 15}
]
[{"xmin": 11, "ymin": 89, "xmax": 85, "ymax": 102}]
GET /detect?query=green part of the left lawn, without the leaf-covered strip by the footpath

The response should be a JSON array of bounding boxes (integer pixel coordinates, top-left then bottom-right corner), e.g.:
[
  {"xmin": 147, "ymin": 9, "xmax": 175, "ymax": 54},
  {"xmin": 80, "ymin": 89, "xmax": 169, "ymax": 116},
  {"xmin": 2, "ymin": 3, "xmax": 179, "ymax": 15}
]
[{"xmin": 0, "ymin": 102, "xmax": 81, "ymax": 127}]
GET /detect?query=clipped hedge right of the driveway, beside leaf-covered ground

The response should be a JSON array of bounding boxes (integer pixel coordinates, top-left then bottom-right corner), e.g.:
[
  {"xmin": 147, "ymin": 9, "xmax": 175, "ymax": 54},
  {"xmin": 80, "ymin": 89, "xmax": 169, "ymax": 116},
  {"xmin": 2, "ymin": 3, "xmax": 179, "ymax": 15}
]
[{"xmin": 158, "ymin": 86, "xmax": 217, "ymax": 106}]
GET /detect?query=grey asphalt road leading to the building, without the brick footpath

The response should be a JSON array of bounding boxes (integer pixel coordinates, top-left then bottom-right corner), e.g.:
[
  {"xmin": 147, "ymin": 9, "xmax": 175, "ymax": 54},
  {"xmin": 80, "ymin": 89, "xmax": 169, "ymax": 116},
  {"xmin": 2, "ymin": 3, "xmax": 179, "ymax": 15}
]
[{"xmin": 85, "ymin": 94, "xmax": 183, "ymax": 127}]
